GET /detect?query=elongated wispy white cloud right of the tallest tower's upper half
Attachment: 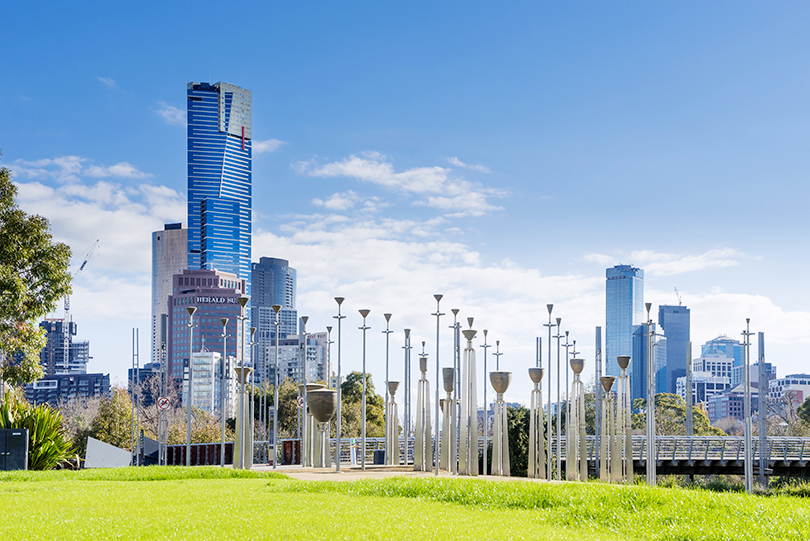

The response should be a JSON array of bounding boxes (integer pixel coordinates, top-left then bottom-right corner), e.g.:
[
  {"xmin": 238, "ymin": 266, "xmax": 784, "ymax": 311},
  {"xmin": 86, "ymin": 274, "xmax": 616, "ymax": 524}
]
[{"xmin": 294, "ymin": 152, "xmax": 507, "ymax": 216}]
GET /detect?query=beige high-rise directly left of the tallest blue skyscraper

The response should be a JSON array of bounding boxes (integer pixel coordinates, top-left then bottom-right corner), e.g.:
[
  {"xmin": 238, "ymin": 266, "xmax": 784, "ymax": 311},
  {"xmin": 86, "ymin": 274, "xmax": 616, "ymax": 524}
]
[{"xmin": 151, "ymin": 224, "xmax": 188, "ymax": 363}]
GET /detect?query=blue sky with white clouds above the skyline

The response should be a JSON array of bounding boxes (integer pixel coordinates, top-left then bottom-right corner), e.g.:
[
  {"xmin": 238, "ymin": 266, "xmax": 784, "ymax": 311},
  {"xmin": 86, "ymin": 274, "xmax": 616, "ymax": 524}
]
[{"xmin": 0, "ymin": 1, "xmax": 810, "ymax": 399}]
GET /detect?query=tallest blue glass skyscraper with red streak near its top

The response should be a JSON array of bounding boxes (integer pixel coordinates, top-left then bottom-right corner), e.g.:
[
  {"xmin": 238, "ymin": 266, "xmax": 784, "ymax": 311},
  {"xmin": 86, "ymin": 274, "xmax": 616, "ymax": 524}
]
[{"xmin": 187, "ymin": 82, "xmax": 253, "ymax": 294}]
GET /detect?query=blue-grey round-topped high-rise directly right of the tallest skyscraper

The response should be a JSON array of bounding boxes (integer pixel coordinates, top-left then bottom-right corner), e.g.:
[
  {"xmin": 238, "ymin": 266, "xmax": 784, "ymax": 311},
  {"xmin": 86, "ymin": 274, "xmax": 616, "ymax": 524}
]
[{"xmin": 250, "ymin": 257, "xmax": 298, "ymax": 382}]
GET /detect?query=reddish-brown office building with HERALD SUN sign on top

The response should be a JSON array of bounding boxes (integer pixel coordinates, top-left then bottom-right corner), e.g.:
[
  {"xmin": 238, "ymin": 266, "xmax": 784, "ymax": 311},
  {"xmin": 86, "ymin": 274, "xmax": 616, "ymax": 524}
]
[{"xmin": 167, "ymin": 269, "xmax": 250, "ymax": 391}]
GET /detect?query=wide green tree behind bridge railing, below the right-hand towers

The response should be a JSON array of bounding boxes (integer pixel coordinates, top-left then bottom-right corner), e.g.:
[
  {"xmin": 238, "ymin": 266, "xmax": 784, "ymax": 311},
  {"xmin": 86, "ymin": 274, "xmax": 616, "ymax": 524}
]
[{"xmin": 633, "ymin": 393, "xmax": 726, "ymax": 436}]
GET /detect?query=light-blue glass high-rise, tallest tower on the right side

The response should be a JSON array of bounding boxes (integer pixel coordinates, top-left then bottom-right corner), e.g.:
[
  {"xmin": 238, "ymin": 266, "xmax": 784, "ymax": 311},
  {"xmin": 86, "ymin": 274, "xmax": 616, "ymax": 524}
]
[{"xmin": 604, "ymin": 265, "xmax": 646, "ymax": 380}]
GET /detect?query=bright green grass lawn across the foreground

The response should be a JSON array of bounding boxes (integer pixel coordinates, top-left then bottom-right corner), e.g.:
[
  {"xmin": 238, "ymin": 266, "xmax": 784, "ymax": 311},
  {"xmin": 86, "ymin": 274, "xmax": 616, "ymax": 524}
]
[{"xmin": 0, "ymin": 467, "xmax": 810, "ymax": 540}]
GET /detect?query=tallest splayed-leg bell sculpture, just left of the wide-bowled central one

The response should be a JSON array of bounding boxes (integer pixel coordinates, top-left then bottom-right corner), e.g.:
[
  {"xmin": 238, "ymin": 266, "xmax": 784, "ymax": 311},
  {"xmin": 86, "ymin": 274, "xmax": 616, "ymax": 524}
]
[{"xmin": 458, "ymin": 317, "xmax": 478, "ymax": 475}]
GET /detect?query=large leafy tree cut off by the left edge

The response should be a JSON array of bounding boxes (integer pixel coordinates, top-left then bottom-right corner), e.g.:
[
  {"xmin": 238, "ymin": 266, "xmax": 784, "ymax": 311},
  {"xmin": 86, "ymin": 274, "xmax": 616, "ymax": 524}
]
[{"xmin": 0, "ymin": 162, "xmax": 71, "ymax": 385}]
